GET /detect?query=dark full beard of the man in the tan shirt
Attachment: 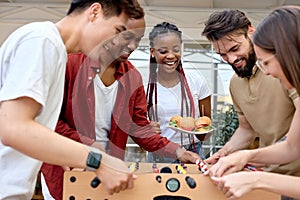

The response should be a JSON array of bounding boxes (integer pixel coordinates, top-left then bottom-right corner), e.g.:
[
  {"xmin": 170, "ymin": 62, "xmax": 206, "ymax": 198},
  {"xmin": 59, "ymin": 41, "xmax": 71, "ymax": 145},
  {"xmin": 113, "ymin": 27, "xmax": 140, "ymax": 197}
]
[{"xmin": 228, "ymin": 42, "xmax": 256, "ymax": 78}]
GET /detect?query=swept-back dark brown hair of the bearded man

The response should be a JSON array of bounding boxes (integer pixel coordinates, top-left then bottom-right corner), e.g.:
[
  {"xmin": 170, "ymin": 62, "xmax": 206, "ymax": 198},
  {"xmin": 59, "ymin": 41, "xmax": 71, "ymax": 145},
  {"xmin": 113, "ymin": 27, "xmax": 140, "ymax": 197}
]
[{"xmin": 202, "ymin": 9, "xmax": 251, "ymax": 41}]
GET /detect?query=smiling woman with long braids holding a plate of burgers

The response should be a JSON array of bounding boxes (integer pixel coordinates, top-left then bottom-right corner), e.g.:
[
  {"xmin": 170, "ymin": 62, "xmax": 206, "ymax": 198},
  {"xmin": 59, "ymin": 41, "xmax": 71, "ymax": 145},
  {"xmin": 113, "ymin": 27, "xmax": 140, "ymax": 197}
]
[{"xmin": 146, "ymin": 22, "xmax": 211, "ymax": 162}]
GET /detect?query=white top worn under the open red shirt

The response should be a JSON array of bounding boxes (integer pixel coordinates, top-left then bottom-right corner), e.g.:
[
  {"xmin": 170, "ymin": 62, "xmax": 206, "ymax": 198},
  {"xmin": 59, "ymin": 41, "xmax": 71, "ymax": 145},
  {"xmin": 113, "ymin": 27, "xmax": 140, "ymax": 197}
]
[{"xmin": 94, "ymin": 75, "xmax": 118, "ymax": 152}]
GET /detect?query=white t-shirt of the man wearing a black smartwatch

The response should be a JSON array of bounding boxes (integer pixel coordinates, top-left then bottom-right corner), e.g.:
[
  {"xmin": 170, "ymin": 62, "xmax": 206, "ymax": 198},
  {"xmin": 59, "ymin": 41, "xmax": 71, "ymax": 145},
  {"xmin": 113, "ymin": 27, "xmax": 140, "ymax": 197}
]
[{"xmin": 0, "ymin": 22, "xmax": 67, "ymax": 200}]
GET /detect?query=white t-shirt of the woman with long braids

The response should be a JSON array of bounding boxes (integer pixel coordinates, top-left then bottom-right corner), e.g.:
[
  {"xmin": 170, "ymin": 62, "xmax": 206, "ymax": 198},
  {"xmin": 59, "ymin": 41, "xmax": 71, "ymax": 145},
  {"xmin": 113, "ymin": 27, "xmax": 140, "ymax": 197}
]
[{"xmin": 148, "ymin": 72, "xmax": 211, "ymax": 145}]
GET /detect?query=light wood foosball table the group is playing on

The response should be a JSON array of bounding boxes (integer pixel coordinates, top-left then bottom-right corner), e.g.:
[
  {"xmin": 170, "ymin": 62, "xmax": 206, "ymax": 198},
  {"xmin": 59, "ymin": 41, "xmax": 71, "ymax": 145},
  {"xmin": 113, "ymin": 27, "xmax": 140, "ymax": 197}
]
[{"xmin": 63, "ymin": 163, "xmax": 280, "ymax": 200}]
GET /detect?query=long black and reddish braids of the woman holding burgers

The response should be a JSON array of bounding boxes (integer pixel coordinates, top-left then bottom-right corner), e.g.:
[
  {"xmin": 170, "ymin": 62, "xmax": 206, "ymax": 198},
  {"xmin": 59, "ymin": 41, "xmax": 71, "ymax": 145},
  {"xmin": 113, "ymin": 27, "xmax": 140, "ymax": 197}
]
[{"xmin": 147, "ymin": 22, "xmax": 195, "ymax": 122}]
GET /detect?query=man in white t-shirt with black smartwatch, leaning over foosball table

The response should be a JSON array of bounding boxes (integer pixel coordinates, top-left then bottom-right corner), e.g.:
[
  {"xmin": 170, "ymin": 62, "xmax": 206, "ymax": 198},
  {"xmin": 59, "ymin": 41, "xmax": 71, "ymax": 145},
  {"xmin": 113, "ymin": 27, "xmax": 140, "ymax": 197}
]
[{"xmin": 0, "ymin": 0, "xmax": 144, "ymax": 199}]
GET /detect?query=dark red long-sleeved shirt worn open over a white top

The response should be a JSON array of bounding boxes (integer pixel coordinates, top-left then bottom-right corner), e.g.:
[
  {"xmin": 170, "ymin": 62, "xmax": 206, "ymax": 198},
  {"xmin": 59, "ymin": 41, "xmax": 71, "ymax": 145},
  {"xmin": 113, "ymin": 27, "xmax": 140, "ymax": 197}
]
[{"xmin": 41, "ymin": 54, "xmax": 180, "ymax": 200}]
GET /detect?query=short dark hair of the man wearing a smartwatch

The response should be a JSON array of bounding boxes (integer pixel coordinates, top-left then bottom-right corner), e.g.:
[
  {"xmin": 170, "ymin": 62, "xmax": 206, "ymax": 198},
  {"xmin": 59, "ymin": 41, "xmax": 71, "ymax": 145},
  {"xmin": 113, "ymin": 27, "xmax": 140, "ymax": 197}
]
[{"xmin": 67, "ymin": 0, "xmax": 145, "ymax": 19}]
